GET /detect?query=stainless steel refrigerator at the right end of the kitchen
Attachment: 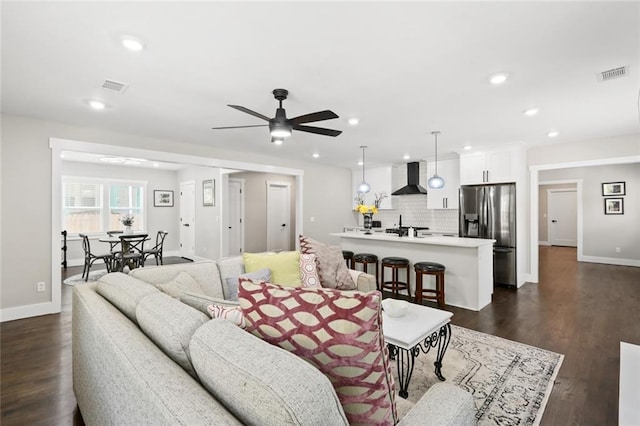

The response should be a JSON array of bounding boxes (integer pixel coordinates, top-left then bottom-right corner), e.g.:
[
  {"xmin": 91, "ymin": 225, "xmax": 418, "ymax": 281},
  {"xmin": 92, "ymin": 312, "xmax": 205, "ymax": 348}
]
[{"xmin": 460, "ymin": 183, "xmax": 517, "ymax": 286}]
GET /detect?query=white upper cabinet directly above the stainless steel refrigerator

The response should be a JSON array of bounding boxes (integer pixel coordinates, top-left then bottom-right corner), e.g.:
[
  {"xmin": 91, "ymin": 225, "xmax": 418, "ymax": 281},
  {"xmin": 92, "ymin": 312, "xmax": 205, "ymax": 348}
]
[{"xmin": 460, "ymin": 147, "xmax": 526, "ymax": 185}]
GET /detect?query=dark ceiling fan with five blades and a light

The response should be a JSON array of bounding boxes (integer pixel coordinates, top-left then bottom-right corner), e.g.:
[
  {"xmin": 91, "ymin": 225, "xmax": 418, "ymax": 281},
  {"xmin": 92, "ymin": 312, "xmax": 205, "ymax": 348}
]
[{"xmin": 212, "ymin": 89, "xmax": 342, "ymax": 144}]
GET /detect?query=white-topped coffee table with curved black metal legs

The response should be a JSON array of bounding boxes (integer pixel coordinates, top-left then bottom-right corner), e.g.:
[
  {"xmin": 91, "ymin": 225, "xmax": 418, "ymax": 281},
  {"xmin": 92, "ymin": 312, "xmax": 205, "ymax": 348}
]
[{"xmin": 382, "ymin": 303, "xmax": 453, "ymax": 398}]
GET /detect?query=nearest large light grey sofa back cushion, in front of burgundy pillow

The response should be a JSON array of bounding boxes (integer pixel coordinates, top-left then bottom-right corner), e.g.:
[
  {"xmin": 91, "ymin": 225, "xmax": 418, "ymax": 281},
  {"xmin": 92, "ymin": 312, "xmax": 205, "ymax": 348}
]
[{"xmin": 190, "ymin": 319, "xmax": 347, "ymax": 425}]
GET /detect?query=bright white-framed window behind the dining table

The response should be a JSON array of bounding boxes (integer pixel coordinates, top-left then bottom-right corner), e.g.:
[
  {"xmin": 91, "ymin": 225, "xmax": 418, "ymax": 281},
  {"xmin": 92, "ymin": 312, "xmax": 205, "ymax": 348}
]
[{"xmin": 62, "ymin": 177, "xmax": 146, "ymax": 234}]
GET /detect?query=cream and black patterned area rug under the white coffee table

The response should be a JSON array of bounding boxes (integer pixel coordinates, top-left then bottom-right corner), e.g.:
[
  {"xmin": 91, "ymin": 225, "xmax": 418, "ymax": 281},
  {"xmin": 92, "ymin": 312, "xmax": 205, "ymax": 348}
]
[{"xmin": 392, "ymin": 325, "xmax": 564, "ymax": 425}]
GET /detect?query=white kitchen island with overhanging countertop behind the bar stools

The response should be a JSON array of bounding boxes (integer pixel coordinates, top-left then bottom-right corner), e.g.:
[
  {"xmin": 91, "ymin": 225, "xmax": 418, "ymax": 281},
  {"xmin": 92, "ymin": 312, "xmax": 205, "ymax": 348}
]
[{"xmin": 331, "ymin": 232, "xmax": 495, "ymax": 311}]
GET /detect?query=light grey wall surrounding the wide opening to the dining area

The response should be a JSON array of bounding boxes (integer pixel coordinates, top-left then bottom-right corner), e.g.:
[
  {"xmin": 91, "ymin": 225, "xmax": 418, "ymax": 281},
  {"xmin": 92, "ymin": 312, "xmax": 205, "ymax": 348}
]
[{"xmin": 0, "ymin": 114, "xmax": 353, "ymax": 321}]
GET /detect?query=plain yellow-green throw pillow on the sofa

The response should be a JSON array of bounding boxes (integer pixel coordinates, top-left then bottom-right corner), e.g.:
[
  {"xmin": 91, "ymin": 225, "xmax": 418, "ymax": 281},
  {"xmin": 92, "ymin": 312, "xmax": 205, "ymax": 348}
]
[{"xmin": 242, "ymin": 251, "xmax": 302, "ymax": 287}]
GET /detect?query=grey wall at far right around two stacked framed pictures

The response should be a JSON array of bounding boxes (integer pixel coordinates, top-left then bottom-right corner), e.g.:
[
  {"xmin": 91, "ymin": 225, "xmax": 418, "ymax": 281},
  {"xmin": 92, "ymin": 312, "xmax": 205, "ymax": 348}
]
[{"xmin": 540, "ymin": 164, "xmax": 640, "ymax": 265}]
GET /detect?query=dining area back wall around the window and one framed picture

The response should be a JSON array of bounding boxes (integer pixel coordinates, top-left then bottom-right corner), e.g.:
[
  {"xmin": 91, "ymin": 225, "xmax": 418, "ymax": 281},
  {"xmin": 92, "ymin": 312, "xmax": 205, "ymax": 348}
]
[{"xmin": 61, "ymin": 161, "xmax": 179, "ymax": 266}]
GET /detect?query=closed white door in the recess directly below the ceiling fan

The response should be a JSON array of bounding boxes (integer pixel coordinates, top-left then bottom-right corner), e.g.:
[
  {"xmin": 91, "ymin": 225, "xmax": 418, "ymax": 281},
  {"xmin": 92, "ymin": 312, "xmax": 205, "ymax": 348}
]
[{"xmin": 267, "ymin": 181, "xmax": 292, "ymax": 251}]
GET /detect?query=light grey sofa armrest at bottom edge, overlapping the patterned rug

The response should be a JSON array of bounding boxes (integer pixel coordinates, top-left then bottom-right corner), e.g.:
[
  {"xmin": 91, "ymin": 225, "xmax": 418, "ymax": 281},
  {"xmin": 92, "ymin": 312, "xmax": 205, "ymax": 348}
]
[{"xmin": 398, "ymin": 383, "xmax": 477, "ymax": 426}]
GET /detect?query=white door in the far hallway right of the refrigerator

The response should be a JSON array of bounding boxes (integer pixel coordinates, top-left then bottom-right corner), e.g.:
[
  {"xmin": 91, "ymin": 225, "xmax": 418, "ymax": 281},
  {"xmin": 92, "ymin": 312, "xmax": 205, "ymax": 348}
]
[{"xmin": 547, "ymin": 189, "xmax": 578, "ymax": 247}]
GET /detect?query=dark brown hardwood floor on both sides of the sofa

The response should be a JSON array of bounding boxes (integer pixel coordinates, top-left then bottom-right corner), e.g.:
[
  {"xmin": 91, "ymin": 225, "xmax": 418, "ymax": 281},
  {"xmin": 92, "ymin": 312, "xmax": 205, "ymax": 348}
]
[{"xmin": 0, "ymin": 247, "xmax": 640, "ymax": 426}]
